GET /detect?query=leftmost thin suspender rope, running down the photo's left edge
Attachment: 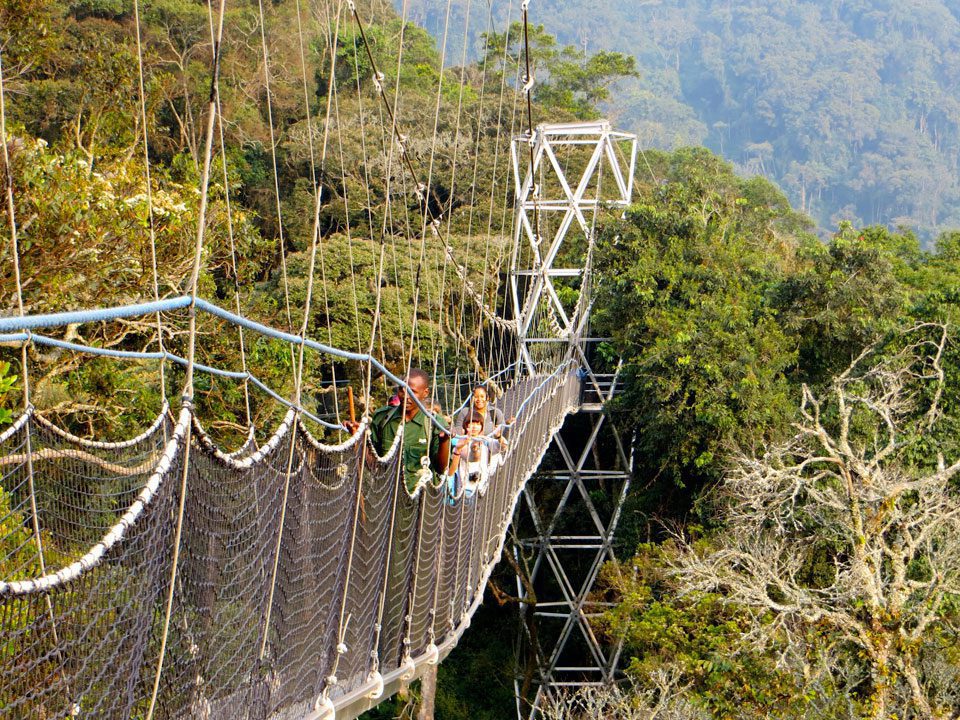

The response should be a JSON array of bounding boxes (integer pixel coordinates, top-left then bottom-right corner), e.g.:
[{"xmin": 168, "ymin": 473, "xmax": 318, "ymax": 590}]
[{"xmin": 0, "ymin": 42, "xmax": 76, "ymax": 708}]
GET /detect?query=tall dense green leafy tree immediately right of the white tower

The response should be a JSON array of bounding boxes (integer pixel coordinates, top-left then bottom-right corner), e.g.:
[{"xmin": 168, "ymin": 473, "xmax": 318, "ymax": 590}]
[{"xmin": 594, "ymin": 151, "xmax": 795, "ymax": 496}]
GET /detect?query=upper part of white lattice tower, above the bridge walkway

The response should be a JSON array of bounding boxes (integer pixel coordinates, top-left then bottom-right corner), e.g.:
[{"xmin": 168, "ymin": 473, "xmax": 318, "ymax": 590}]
[{"xmin": 510, "ymin": 120, "xmax": 637, "ymax": 372}]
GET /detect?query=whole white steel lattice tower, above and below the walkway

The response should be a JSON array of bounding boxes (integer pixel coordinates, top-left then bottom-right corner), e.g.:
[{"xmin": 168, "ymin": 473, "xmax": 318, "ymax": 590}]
[{"xmin": 510, "ymin": 120, "xmax": 637, "ymax": 719}]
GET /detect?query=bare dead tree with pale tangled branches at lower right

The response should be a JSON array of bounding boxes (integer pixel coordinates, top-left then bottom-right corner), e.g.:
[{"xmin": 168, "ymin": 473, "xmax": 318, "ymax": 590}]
[{"xmin": 672, "ymin": 324, "xmax": 960, "ymax": 718}]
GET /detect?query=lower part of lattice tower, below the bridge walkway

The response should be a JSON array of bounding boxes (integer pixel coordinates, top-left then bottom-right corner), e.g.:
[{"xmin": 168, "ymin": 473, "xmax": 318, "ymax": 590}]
[{"xmin": 512, "ymin": 372, "xmax": 632, "ymax": 720}]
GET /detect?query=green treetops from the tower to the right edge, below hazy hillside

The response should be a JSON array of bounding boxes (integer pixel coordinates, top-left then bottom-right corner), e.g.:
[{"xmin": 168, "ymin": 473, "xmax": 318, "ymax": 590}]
[{"xmin": 594, "ymin": 143, "xmax": 960, "ymax": 506}]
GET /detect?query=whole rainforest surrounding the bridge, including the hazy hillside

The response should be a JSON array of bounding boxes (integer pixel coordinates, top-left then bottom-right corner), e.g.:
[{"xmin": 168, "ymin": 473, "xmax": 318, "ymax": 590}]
[{"xmin": 0, "ymin": 0, "xmax": 960, "ymax": 720}]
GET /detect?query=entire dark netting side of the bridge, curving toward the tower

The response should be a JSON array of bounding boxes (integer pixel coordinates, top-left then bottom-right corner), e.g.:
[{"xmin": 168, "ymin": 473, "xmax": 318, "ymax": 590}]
[{"xmin": 0, "ymin": 369, "xmax": 578, "ymax": 720}]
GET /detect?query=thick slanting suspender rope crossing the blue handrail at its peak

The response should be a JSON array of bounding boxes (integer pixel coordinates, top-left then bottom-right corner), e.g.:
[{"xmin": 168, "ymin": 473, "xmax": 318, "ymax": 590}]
[{"xmin": 146, "ymin": 0, "xmax": 226, "ymax": 720}]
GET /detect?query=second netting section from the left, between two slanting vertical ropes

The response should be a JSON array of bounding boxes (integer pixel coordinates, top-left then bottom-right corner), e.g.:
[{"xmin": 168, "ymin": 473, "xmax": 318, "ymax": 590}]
[{"xmin": 150, "ymin": 423, "xmax": 290, "ymax": 718}]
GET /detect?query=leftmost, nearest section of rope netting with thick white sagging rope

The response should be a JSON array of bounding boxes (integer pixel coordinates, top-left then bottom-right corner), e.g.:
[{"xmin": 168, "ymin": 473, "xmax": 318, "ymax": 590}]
[{"xmin": 0, "ymin": 415, "xmax": 186, "ymax": 718}]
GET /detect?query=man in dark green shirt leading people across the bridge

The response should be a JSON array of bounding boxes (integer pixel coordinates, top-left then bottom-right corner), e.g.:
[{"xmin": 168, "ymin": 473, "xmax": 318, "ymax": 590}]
[{"xmin": 348, "ymin": 368, "xmax": 450, "ymax": 492}]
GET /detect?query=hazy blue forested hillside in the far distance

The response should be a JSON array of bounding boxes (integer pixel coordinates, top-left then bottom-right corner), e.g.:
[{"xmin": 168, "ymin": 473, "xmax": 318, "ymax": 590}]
[{"xmin": 409, "ymin": 0, "xmax": 960, "ymax": 239}]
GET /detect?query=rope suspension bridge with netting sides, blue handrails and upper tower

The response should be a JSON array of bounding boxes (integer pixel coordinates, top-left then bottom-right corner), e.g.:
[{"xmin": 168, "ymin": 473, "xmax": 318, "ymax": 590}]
[{"xmin": 0, "ymin": 0, "xmax": 637, "ymax": 720}]
